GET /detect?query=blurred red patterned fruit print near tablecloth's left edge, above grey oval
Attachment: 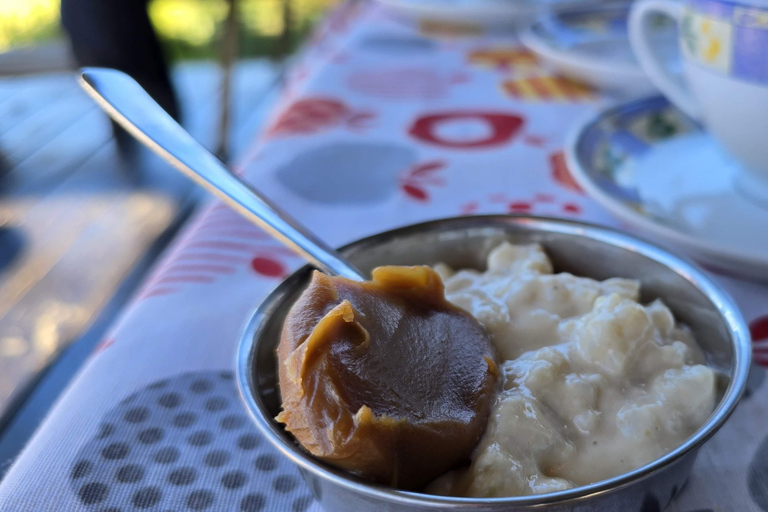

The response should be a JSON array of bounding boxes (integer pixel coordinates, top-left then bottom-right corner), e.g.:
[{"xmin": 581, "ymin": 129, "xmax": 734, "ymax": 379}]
[{"xmin": 267, "ymin": 97, "xmax": 376, "ymax": 138}]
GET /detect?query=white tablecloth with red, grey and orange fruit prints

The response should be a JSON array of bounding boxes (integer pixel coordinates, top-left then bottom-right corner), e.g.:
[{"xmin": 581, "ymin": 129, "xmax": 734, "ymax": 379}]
[{"xmin": 0, "ymin": 2, "xmax": 768, "ymax": 512}]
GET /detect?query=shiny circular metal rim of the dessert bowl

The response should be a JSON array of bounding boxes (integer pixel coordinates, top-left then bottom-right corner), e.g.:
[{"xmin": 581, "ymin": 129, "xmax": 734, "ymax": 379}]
[{"xmin": 237, "ymin": 215, "xmax": 751, "ymax": 508}]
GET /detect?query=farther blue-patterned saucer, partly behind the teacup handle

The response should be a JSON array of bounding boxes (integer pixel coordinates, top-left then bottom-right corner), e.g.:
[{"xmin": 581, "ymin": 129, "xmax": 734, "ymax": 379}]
[{"xmin": 520, "ymin": 1, "xmax": 680, "ymax": 95}]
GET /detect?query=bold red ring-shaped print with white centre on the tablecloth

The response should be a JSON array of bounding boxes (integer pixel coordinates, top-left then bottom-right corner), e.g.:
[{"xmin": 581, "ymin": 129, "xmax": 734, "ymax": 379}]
[{"xmin": 408, "ymin": 110, "xmax": 524, "ymax": 149}]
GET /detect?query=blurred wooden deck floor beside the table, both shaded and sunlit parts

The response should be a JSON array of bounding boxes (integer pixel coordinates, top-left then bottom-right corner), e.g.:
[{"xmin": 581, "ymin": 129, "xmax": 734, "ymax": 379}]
[{"xmin": 0, "ymin": 59, "xmax": 274, "ymax": 421}]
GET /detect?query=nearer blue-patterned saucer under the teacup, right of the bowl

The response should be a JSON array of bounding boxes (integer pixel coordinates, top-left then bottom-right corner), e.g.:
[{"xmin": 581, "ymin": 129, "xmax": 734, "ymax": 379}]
[{"xmin": 566, "ymin": 97, "xmax": 768, "ymax": 281}]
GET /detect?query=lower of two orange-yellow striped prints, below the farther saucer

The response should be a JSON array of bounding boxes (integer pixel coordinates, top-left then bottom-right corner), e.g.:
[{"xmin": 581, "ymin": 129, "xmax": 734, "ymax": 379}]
[{"xmin": 501, "ymin": 76, "xmax": 597, "ymax": 103}]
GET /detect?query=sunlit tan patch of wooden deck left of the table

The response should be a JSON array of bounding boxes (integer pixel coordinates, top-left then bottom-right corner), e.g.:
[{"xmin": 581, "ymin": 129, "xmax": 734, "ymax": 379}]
[{"xmin": 0, "ymin": 182, "xmax": 176, "ymax": 410}]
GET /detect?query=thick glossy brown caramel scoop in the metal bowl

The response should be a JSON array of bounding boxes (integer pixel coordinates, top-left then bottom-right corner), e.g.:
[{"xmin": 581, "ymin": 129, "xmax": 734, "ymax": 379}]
[{"xmin": 277, "ymin": 266, "xmax": 498, "ymax": 490}]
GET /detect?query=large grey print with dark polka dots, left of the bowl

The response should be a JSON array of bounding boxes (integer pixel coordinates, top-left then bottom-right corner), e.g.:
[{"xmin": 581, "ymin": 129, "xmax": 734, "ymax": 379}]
[{"xmin": 69, "ymin": 371, "xmax": 313, "ymax": 512}]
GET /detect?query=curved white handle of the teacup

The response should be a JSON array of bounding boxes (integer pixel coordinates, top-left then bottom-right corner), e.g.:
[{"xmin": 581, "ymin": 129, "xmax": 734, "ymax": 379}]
[{"xmin": 629, "ymin": 0, "xmax": 701, "ymax": 119}]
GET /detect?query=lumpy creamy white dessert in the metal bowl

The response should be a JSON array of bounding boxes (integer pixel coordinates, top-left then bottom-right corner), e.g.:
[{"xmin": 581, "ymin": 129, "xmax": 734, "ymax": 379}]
[{"xmin": 427, "ymin": 243, "xmax": 716, "ymax": 497}]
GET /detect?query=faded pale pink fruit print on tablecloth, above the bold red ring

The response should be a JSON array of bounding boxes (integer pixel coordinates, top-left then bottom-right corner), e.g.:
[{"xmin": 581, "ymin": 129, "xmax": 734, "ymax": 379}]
[{"xmin": 347, "ymin": 67, "xmax": 471, "ymax": 100}]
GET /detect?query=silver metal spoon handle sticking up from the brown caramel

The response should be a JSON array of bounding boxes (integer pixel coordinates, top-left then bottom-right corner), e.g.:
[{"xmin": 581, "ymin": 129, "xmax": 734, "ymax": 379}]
[{"xmin": 80, "ymin": 68, "xmax": 365, "ymax": 281}]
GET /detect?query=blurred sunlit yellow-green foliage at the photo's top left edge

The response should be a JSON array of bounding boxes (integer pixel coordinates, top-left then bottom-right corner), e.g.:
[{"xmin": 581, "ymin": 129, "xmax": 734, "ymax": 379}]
[{"xmin": 0, "ymin": 0, "xmax": 338, "ymax": 61}]
